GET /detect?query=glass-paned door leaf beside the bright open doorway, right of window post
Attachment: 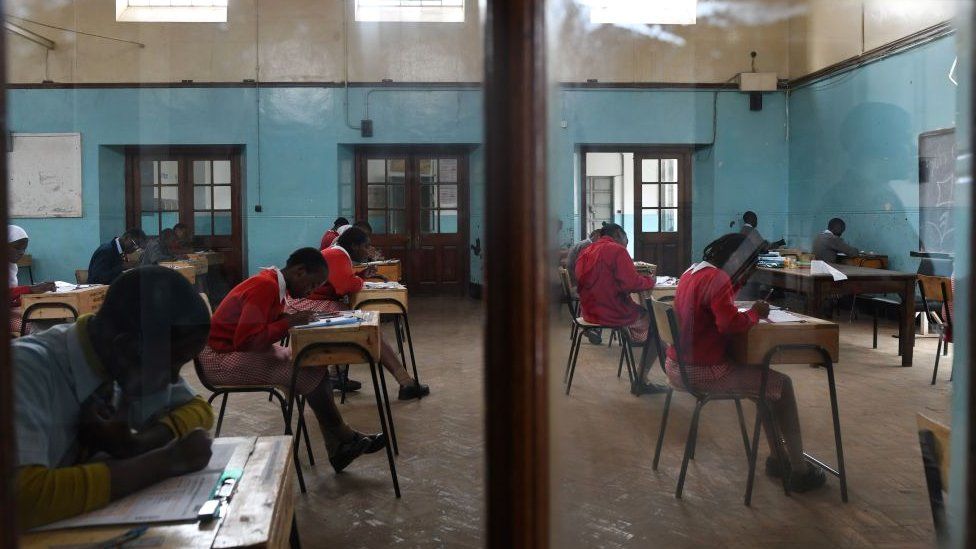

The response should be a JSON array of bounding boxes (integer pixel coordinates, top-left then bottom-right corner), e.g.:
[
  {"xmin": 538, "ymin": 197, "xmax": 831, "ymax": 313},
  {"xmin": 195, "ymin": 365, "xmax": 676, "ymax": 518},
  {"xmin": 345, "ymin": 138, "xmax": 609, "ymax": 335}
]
[{"xmin": 634, "ymin": 150, "xmax": 691, "ymax": 276}]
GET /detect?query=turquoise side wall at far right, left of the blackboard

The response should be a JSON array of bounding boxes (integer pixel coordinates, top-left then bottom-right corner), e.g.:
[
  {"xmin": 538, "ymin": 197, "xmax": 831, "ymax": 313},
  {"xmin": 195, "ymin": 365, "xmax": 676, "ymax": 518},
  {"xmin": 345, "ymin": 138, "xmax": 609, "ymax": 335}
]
[{"xmin": 787, "ymin": 36, "xmax": 957, "ymax": 271}]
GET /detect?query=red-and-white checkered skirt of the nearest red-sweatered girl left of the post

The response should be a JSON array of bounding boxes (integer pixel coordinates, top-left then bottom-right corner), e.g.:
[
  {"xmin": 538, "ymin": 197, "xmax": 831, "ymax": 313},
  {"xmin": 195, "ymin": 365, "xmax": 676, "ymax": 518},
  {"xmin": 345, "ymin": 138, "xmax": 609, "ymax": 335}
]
[{"xmin": 199, "ymin": 345, "xmax": 328, "ymax": 395}]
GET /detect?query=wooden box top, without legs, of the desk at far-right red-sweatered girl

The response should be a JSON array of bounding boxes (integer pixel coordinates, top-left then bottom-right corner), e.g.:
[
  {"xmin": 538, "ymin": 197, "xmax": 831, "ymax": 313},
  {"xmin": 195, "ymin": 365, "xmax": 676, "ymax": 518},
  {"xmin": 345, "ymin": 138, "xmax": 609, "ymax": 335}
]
[{"xmin": 729, "ymin": 313, "xmax": 840, "ymax": 365}]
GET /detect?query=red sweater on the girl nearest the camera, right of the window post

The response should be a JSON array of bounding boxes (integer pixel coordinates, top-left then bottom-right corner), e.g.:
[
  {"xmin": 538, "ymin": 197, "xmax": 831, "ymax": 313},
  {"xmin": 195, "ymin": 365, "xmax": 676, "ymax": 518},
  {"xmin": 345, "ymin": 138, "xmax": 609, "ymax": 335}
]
[{"xmin": 668, "ymin": 264, "xmax": 759, "ymax": 366}]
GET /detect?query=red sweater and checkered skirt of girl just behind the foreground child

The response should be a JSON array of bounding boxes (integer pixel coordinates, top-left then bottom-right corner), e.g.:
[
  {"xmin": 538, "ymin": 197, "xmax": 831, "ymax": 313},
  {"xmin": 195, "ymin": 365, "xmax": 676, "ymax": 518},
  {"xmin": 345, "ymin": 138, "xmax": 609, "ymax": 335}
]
[{"xmin": 200, "ymin": 267, "xmax": 326, "ymax": 395}]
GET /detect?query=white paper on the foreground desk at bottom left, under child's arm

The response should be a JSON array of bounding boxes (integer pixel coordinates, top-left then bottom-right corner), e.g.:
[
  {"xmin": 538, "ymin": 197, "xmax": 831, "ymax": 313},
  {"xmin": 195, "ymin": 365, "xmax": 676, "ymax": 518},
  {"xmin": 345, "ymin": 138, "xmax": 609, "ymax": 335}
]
[{"xmin": 34, "ymin": 438, "xmax": 246, "ymax": 532}]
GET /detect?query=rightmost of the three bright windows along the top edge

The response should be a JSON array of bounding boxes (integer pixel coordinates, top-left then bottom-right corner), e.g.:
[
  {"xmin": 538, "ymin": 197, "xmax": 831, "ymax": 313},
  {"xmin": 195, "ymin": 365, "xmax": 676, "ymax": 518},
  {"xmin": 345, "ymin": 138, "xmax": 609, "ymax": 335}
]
[{"xmin": 581, "ymin": 0, "xmax": 698, "ymax": 25}]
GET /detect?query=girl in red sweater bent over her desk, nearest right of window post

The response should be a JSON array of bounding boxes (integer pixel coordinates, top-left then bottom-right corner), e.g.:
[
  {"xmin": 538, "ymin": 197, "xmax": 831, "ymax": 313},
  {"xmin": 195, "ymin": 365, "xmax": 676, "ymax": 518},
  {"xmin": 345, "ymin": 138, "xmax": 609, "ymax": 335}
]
[{"xmin": 665, "ymin": 233, "xmax": 826, "ymax": 492}]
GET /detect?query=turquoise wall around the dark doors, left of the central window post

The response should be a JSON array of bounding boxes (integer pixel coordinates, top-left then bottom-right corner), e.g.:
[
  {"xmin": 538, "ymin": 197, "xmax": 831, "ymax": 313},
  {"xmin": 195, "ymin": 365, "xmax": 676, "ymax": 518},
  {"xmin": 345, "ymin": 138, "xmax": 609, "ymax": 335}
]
[{"xmin": 7, "ymin": 87, "xmax": 484, "ymax": 281}]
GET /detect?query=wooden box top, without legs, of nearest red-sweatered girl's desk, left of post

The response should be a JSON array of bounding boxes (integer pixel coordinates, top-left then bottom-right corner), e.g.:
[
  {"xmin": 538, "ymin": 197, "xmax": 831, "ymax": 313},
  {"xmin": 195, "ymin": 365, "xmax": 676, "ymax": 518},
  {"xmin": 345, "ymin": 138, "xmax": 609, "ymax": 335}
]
[{"xmin": 288, "ymin": 312, "xmax": 380, "ymax": 367}]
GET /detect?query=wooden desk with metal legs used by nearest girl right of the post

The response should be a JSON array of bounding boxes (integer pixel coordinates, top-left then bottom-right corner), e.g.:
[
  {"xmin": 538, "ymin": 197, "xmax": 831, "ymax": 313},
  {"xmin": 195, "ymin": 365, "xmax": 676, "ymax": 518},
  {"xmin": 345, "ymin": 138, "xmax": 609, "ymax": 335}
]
[{"xmin": 729, "ymin": 303, "xmax": 847, "ymax": 502}]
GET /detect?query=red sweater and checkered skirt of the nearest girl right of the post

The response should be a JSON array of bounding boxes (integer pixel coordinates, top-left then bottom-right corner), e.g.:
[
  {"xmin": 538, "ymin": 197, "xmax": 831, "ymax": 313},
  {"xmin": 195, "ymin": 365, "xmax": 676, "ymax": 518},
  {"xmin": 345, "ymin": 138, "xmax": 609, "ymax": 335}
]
[{"xmin": 664, "ymin": 261, "xmax": 787, "ymax": 400}]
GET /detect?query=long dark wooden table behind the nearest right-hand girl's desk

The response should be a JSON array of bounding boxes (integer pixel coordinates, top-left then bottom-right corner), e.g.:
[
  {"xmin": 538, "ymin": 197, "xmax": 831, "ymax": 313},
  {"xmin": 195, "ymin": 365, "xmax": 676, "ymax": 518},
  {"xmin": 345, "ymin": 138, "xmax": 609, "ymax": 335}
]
[{"xmin": 750, "ymin": 264, "xmax": 915, "ymax": 366}]
